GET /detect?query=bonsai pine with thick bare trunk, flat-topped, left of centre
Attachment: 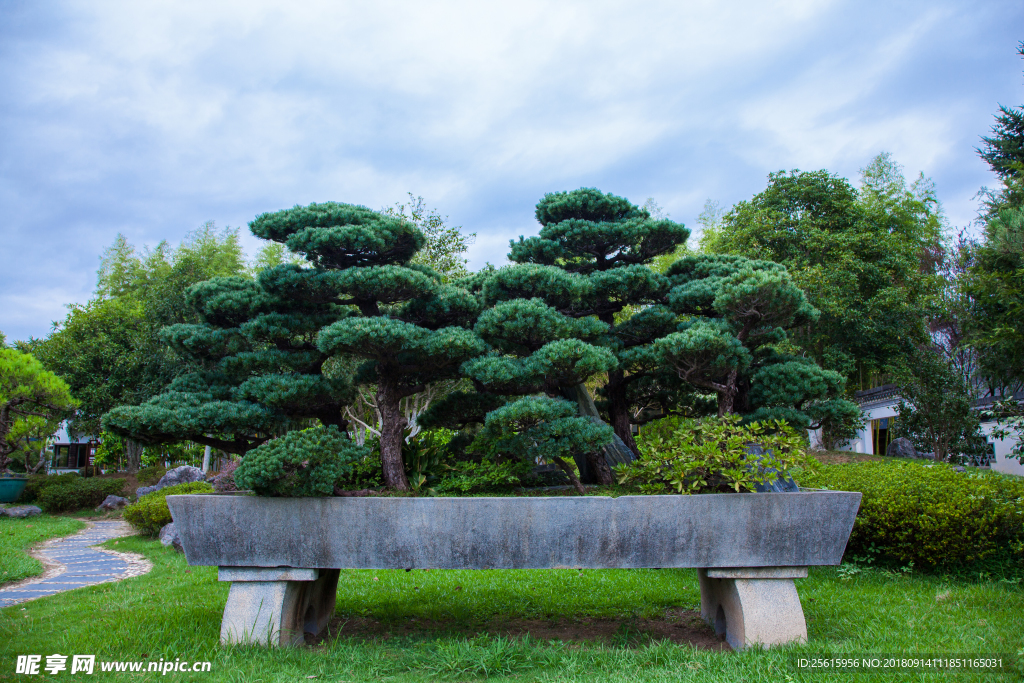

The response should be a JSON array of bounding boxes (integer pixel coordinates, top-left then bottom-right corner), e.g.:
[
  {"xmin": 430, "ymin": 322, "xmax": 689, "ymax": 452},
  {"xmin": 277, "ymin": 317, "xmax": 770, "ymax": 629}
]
[{"xmin": 250, "ymin": 203, "xmax": 485, "ymax": 490}]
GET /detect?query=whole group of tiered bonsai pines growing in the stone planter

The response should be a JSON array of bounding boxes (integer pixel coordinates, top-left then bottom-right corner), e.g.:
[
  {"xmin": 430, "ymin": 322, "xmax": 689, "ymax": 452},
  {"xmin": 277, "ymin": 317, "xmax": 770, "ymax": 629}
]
[{"xmin": 97, "ymin": 188, "xmax": 849, "ymax": 495}]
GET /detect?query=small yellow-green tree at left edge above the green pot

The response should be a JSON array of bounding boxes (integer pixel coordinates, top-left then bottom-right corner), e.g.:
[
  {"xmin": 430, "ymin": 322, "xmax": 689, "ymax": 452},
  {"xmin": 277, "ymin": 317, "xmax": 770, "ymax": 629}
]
[{"xmin": 0, "ymin": 348, "xmax": 78, "ymax": 472}]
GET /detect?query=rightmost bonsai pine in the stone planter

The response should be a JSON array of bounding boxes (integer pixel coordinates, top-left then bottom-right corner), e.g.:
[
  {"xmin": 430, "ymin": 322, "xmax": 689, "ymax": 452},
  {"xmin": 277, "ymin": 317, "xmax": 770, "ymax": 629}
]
[{"xmin": 654, "ymin": 255, "xmax": 859, "ymax": 428}]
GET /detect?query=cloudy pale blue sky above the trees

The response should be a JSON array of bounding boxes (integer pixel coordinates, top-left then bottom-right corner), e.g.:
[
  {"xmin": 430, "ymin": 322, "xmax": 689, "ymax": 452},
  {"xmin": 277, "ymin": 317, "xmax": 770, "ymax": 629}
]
[{"xmin": 0, "ymin": 0, "xmax": 1024, "ymax": 341}]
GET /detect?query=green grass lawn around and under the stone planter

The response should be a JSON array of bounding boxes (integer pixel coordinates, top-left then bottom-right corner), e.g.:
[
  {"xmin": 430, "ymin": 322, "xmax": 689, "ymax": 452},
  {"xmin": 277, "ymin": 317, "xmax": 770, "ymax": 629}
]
[{"xmin": 0, "ymin": 537, "xmax": 1024, "ymax": 683}]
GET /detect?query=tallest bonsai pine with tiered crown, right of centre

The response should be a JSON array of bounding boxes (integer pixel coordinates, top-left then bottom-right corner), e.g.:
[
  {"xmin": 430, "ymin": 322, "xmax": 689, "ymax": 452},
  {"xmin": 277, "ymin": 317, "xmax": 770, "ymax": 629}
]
[{"xmin": 501, "ymin": 187, "xmax": 689, "ymax": 454}]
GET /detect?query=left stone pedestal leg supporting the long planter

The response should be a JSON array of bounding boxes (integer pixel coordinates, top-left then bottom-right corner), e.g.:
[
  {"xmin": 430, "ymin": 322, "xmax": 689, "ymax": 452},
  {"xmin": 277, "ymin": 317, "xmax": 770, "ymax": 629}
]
[{"xmin": 217, "ymin": 567, "xmax": 341, "ymax": 645}]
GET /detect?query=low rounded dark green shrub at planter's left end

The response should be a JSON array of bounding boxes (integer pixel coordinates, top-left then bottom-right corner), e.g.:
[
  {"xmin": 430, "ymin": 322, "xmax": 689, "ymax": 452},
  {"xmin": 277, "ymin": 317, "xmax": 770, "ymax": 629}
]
[{"xmin": 234, "ymin": 425, "xmax": 370, "ymax": 498}]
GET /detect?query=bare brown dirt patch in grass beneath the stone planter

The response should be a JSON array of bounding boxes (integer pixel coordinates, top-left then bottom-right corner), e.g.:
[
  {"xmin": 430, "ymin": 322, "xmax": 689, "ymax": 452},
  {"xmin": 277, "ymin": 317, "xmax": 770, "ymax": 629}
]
[{"xmin": 319, "ymin": 609, "xmax": 731, "ymax": 651}]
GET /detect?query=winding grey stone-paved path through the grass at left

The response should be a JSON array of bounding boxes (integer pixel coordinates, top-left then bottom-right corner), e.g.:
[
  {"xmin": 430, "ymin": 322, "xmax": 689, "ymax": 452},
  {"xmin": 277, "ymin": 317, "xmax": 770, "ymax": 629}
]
[{"xmin": 0, "ymin": 521, "xmax": 152, "ymax": 607}]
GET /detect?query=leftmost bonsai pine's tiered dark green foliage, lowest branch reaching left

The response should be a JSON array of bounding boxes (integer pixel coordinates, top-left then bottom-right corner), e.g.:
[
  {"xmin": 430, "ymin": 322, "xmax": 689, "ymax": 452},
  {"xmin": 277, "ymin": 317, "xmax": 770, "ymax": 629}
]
[{"xmin": 103, "ymin": 265, "xmax": 352, "ymax": 455}]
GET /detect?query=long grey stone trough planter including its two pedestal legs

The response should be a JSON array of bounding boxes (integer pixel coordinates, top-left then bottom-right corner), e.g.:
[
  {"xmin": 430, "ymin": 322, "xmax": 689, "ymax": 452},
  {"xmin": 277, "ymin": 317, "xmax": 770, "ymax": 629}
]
[{"xmin": 167, "ymin": 492, "xmax": 860, "ymax": 649}]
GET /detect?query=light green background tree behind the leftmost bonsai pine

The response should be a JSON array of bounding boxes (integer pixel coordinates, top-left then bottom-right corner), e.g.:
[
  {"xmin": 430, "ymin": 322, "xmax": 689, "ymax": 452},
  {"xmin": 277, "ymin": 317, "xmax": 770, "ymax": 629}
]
[{"xmin": 27, "ymin": 222, "xmax": 246, "ymax": 471}]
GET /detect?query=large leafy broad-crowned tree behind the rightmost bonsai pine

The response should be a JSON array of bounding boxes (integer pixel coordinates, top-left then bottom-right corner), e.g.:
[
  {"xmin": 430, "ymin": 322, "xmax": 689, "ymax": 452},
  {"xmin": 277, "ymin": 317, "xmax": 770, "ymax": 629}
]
[{"xmin": 701, "ymin": 154, "xmax": 944, "ymax": 385}]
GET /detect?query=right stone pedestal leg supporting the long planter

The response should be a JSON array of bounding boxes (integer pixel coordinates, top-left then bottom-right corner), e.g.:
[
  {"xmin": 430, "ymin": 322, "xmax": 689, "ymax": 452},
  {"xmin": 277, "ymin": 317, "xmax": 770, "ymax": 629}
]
[{"xmin": 697, "ymin": 567, "xmax": 807, "ymax": 650}]
